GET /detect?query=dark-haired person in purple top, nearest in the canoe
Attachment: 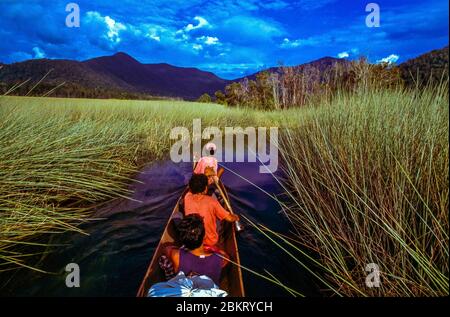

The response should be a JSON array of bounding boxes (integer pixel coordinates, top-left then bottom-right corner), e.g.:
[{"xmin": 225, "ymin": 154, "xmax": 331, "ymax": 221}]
[{"xmin": 164, "ymin": 214, "xmax": 228, "ymax": 285}]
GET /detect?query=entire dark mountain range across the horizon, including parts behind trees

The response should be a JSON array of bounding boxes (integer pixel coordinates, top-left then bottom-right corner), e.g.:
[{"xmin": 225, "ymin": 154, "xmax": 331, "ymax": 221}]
[{"xmin": 0, "ymin": 46, "xmax": 448, "ymax": 100}]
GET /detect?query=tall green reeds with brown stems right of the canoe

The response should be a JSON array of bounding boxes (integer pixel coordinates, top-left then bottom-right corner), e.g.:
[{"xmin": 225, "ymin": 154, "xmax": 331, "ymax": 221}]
[{"xmin": 276, "ymin": 83, "xmax": 449, "ymax": 296}]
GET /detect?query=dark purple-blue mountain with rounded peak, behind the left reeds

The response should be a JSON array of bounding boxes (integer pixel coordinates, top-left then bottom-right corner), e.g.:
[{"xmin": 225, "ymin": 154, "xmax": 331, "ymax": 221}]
[{"xmin": 0, "ymin": 53, "xmax": 229, "ymax": 99}]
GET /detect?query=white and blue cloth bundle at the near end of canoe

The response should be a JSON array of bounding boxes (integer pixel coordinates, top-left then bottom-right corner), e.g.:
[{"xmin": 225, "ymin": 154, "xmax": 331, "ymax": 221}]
[{"xmin": 148, "ymin": 271, "xmax": 228, "ymax": 297}]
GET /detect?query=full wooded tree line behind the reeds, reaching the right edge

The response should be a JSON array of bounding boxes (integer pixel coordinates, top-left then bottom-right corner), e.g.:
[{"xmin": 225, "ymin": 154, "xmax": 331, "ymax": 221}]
[{"xmin": 199, "ymin": 47, "xmax": 449, "ymax": 110}]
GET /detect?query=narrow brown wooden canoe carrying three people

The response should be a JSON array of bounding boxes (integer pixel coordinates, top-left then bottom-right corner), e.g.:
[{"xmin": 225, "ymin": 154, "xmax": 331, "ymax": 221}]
[{"xmin": 137, "ymin": 183, "xmax": 245, "ymax": 297}]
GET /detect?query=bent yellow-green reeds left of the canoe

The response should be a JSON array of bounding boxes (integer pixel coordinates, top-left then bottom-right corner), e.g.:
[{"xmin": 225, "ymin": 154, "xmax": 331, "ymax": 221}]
[{"xmin": 0, "ymin": 97, "xmax": 260, "ymax": 271}]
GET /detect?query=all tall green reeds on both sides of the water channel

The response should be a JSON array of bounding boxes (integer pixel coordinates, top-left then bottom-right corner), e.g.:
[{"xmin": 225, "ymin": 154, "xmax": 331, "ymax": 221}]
[{"xmin": 0, "ymin": 56, "xmax": 449, "ymax": 296}]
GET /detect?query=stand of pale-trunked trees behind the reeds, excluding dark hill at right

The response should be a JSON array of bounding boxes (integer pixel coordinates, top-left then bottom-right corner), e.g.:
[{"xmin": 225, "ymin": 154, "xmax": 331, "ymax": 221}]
[{"xmin": 202, "ymin": 58, "xmax": 402, "ymax": 110}]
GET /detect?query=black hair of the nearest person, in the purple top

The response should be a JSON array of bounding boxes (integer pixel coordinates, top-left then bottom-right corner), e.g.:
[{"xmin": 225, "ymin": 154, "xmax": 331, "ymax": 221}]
[{"xmin": 177, "ymin": 214, "xmax": 205, "ymax": 250}]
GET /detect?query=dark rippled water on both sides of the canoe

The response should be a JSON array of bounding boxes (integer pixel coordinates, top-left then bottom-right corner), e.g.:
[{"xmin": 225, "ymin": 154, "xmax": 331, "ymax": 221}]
[{"xmin": 0, "ymin": 161, "xmax": 317, "ymax": 296}]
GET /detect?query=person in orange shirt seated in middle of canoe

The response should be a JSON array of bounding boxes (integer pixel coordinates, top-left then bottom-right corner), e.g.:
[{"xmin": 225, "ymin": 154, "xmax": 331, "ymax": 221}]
[{"xmin": 184, "ymin": 174, "xmax": 239, "ymax": 250}]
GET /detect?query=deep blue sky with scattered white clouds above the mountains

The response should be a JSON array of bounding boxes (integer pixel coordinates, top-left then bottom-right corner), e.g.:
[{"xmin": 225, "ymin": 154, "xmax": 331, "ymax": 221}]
[{"xmin": 0, "ymin": 0, "xmax": 448, "ymax": 79}]
